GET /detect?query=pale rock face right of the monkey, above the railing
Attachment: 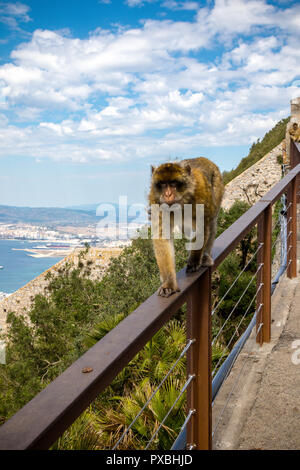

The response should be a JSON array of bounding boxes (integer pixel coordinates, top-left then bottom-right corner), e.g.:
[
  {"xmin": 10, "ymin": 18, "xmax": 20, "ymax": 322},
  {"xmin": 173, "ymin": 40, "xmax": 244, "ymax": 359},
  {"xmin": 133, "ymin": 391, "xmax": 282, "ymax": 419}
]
[{"xmin": 222, "ymin": 140, "xmax": 285, "ymax": 209}]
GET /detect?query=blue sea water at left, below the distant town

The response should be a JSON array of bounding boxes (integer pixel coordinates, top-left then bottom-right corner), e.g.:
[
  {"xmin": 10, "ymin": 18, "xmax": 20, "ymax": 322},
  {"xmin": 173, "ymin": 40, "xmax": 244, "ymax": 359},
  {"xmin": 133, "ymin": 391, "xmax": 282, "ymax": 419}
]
[{"xmin": 0, "ymin": 240, "xmax": 63, "ymax": 297}]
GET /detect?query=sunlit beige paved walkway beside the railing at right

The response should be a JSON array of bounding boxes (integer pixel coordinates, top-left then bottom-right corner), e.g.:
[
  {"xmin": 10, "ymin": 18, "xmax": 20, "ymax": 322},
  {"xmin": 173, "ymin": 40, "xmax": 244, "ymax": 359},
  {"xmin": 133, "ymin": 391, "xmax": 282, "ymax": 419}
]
[{"xmin": 213, "ymin": 241, "xmax": 300, "ymax": 450}]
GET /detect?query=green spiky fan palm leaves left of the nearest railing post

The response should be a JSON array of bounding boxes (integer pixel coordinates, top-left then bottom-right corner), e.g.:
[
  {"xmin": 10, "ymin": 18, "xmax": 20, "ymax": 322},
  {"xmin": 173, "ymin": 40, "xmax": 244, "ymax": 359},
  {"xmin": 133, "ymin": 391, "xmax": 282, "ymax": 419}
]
[{"xmin": 98, "ymin": 377, "xmax": 185, "ymax": 450}]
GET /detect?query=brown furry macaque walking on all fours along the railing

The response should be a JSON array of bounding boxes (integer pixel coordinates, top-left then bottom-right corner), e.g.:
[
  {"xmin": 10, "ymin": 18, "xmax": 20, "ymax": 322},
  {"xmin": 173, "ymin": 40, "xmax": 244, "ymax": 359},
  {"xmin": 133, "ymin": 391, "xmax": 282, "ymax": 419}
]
[{"xmin": 148, "ymin": 157, "xmax": 224, "ymax": 297}]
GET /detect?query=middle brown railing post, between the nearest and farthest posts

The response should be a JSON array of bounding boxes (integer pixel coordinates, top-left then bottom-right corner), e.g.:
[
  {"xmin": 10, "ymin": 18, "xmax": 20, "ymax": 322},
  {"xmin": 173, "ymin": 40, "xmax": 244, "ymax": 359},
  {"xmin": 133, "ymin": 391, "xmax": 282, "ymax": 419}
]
[{"xmin": 256, "ymin": 204, "xmax": 272, "ymax": 345}]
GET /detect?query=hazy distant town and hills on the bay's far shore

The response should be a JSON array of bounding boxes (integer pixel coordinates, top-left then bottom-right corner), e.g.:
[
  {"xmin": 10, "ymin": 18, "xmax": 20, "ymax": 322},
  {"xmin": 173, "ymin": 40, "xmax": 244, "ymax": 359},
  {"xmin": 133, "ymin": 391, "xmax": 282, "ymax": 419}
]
[{"xmin": 0, "ymin": 205, "xmax": 149, "ymax": 257}]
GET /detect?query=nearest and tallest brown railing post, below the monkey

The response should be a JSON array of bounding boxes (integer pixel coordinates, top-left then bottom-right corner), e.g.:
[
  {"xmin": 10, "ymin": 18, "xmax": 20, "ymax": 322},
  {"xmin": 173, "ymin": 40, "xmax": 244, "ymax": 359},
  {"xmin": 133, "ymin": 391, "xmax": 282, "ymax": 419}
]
[{"xmin": 187, "ymin": 268, "xmax": 212, "ymax": 450}]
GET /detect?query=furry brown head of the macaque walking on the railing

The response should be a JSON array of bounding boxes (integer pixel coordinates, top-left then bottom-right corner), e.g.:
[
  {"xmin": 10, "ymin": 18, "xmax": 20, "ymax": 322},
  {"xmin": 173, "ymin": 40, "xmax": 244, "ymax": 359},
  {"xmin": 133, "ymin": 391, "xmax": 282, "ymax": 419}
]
[{"xmin": 152, "ymin": 163, "xmax": 190, "ymax": 205}]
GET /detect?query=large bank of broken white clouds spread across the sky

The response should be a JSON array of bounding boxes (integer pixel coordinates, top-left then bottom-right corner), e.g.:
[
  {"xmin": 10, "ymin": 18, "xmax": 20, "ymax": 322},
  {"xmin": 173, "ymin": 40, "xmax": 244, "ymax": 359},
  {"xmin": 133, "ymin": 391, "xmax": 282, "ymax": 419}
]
[{"xmin": 0, "ymin": 0, "xmax": 300, "ymax": 162}]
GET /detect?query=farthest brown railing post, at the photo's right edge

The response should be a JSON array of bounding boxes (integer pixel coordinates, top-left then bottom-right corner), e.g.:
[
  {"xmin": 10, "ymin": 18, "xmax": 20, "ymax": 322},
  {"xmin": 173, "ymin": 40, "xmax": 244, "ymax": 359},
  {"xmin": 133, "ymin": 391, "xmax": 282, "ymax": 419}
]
[{"xmin": 287, "ymin": 177, "xmax": 297, "ymax": 279}]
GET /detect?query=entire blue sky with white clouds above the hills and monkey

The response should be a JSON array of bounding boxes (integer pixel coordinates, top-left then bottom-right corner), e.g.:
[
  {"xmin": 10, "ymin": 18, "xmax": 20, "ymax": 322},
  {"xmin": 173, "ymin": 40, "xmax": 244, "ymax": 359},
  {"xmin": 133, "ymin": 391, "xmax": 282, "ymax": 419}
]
[{"xmin": 0, "ymin": 0, "xmax": 300, "ymax": 207}]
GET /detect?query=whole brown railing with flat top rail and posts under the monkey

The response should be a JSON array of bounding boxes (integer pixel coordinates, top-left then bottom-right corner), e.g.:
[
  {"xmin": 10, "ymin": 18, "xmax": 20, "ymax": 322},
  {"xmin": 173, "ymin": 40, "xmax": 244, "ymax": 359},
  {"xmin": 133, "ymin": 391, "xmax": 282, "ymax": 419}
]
[{"xmin": 0, "ymin": 142, "xmax": 300, "ymax": 449}]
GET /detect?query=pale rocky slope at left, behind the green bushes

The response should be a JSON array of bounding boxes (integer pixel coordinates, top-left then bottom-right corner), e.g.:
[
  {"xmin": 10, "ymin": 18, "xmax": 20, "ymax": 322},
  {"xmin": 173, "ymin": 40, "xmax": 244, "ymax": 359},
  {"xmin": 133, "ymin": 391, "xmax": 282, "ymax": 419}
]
[{"xmin": 0, "ymin": 248, "xmax": 122, "ymax": 330}]
